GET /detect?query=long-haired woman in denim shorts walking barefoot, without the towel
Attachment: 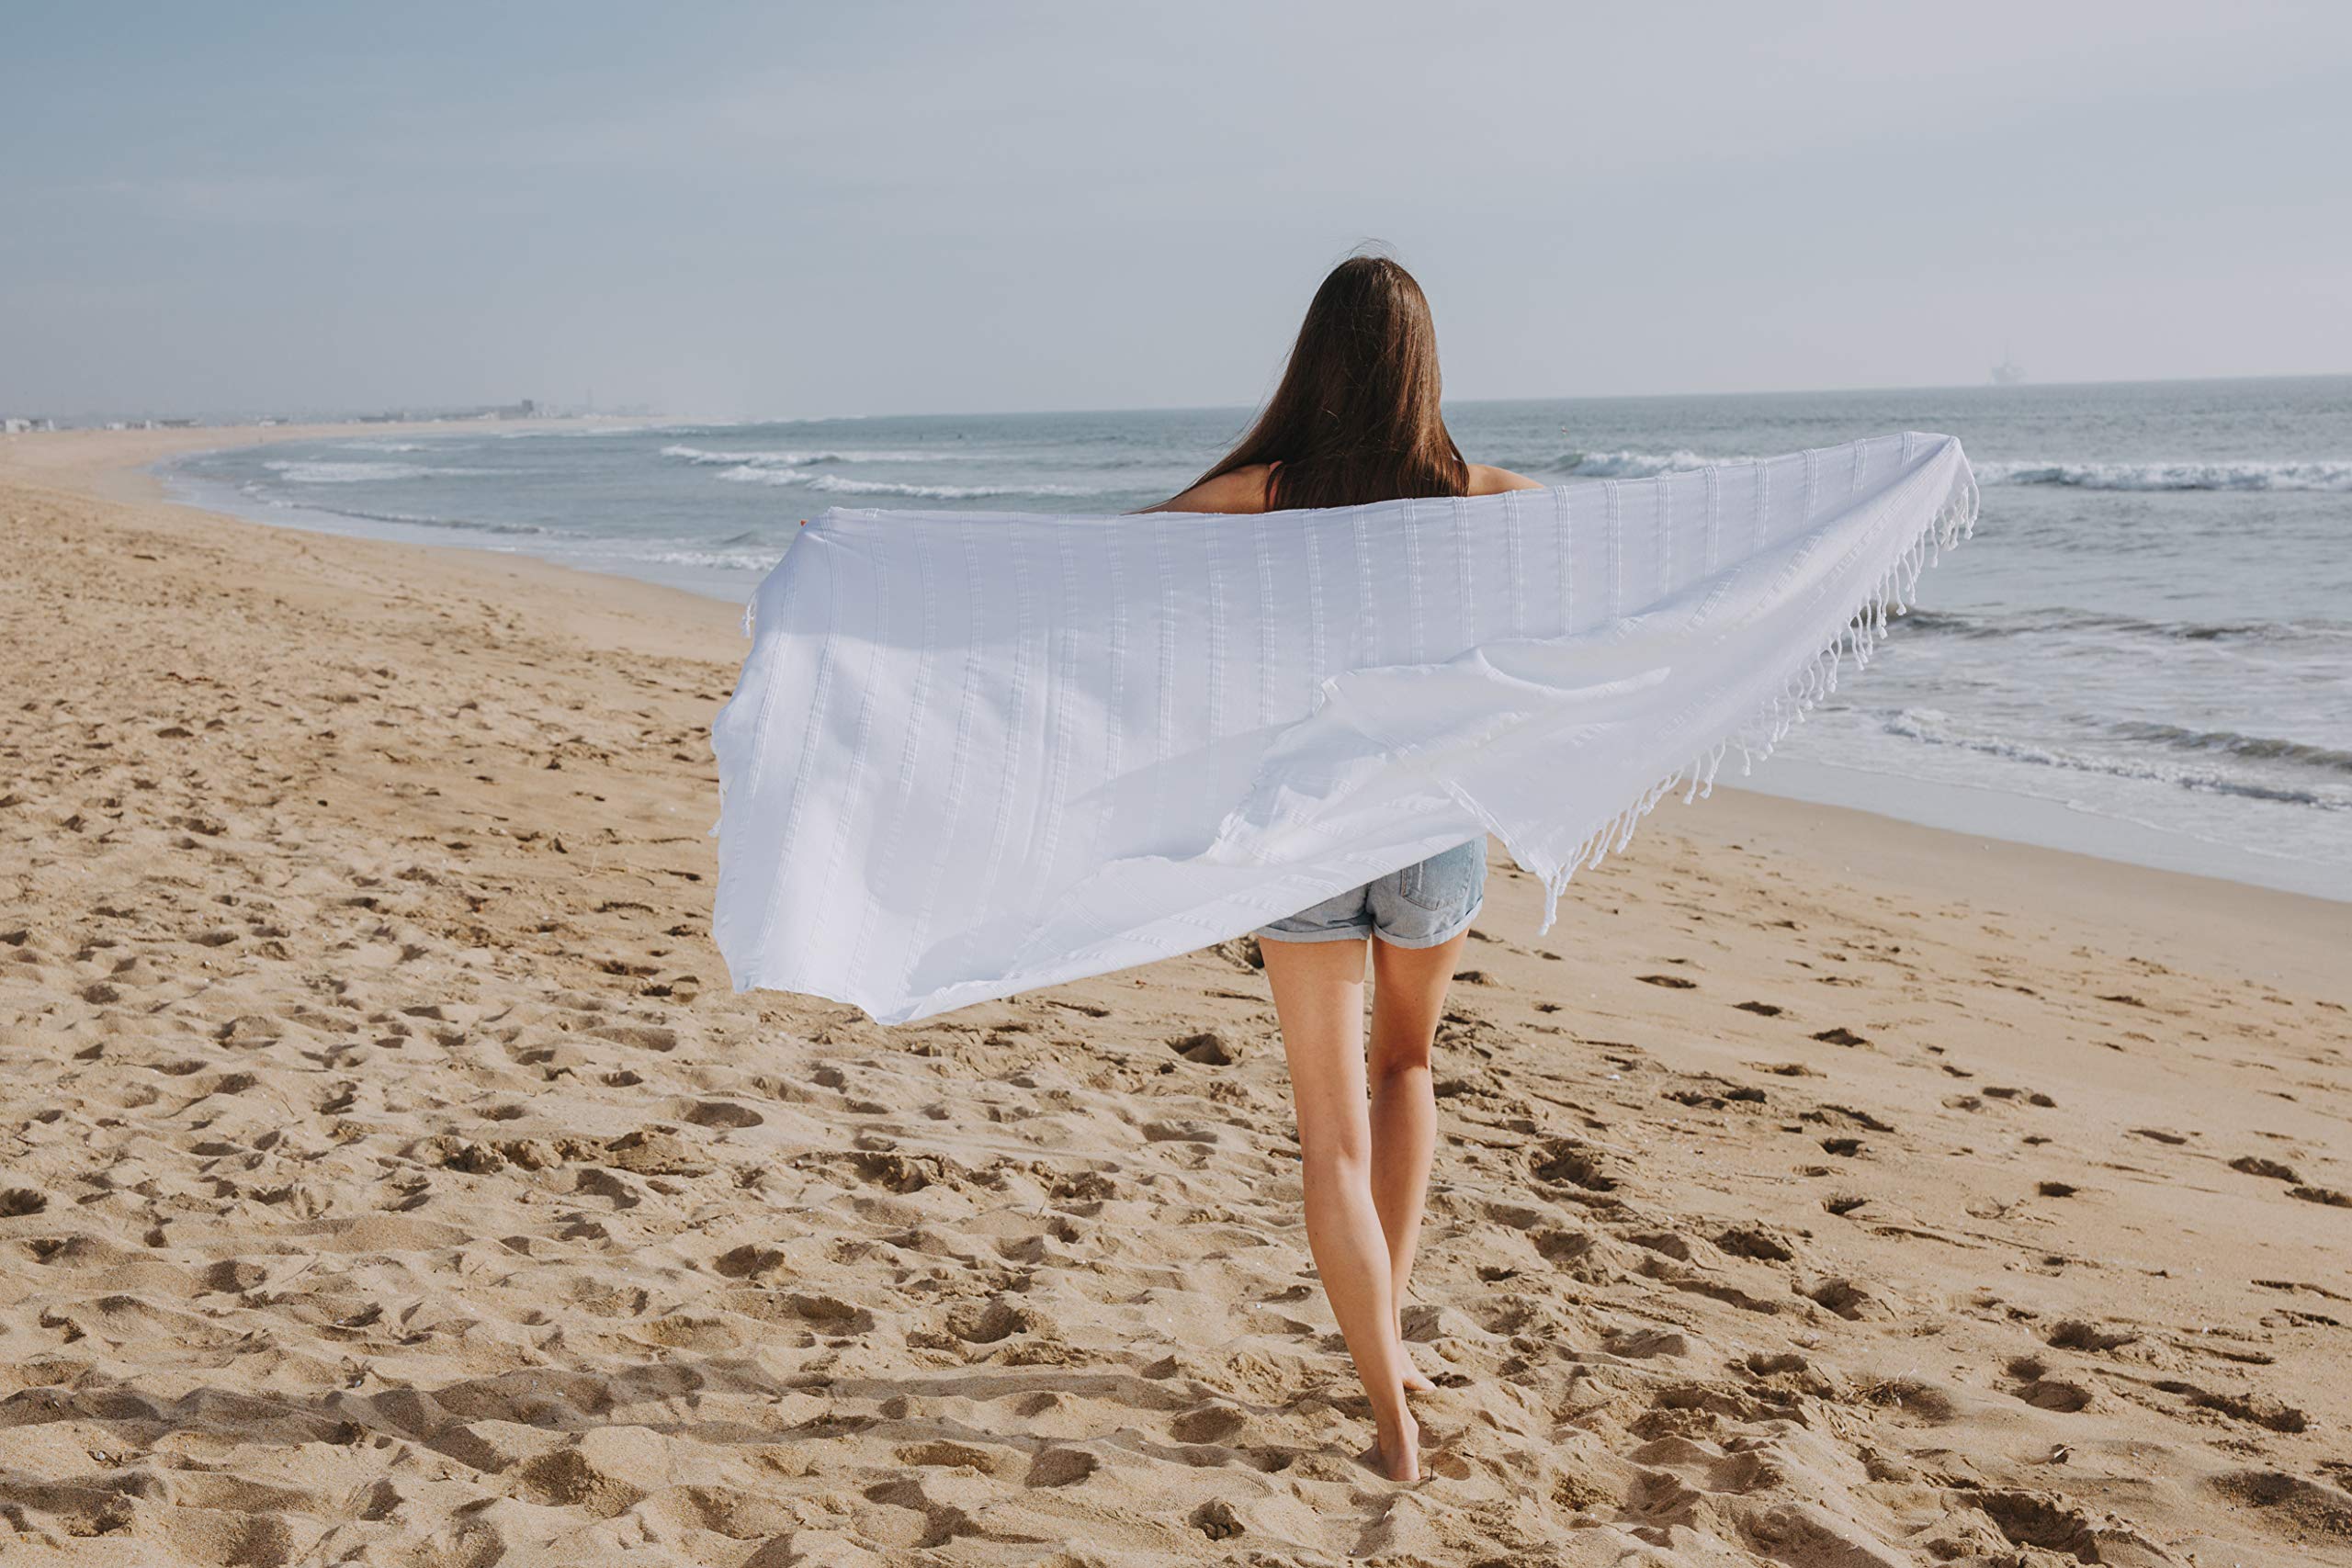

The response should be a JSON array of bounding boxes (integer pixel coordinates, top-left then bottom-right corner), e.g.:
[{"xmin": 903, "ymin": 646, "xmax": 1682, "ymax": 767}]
[{"xmin": 1150, "ymin": 256, "xmax": 1541, "ymax": 1481}]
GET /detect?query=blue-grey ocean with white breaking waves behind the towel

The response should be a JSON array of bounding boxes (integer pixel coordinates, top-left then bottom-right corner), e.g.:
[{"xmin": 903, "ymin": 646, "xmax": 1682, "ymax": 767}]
[{"xmin": 164, "ymin": 376, "xmax": 2352, "ymax": 898}]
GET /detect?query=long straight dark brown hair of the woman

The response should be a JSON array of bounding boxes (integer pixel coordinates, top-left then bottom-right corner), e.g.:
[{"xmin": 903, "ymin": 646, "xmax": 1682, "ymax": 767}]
[{"xmin": 1202, "ymin": 256, "xmax": 1470, "ymax": 508}]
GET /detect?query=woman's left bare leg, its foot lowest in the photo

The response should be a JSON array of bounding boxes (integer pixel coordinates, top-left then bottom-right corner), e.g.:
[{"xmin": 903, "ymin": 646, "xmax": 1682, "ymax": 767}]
[{"xmin": 1261, "ymin": 941, "xmax": 1420, "ymax": 1481}]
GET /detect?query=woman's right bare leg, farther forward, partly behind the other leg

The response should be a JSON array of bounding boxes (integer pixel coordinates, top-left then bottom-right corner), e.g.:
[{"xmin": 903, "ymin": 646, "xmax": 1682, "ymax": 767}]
[{"xmin": 1369, "ymin": 931, "xmax": 1470, "ymax": 1389}]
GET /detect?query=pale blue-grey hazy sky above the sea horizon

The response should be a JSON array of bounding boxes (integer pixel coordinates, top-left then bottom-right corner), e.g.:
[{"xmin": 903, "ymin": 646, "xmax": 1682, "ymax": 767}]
[{"xmin": 0, "ymin": 0, "xmax": 2352, "ymax": 416}]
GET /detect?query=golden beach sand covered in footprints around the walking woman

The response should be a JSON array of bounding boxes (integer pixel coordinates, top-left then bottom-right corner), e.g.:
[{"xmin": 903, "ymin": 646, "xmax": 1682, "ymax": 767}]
[{"xmin": 0, "ymin": 430, "xmax": 2352, "ymax": 1568}]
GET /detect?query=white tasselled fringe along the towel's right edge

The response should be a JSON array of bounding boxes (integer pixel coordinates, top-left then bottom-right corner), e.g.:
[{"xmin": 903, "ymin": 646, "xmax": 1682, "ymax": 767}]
[{"xmin": 1538, "ymin": 468, "xmax": 1978, "ymax": 936}]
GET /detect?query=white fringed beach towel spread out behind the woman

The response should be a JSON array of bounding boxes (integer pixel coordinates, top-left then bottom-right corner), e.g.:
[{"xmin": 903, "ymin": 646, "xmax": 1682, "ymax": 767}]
[{"xmin": 713, "ymin": 433, "xmax": 1975, "ymax": 1022}]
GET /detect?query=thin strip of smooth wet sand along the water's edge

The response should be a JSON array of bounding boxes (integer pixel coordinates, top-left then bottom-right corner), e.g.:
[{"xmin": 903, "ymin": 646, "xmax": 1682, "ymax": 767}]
[{"xmin": 125, "ymin": 419, "xmax": 2352, "ymax": 903}]
